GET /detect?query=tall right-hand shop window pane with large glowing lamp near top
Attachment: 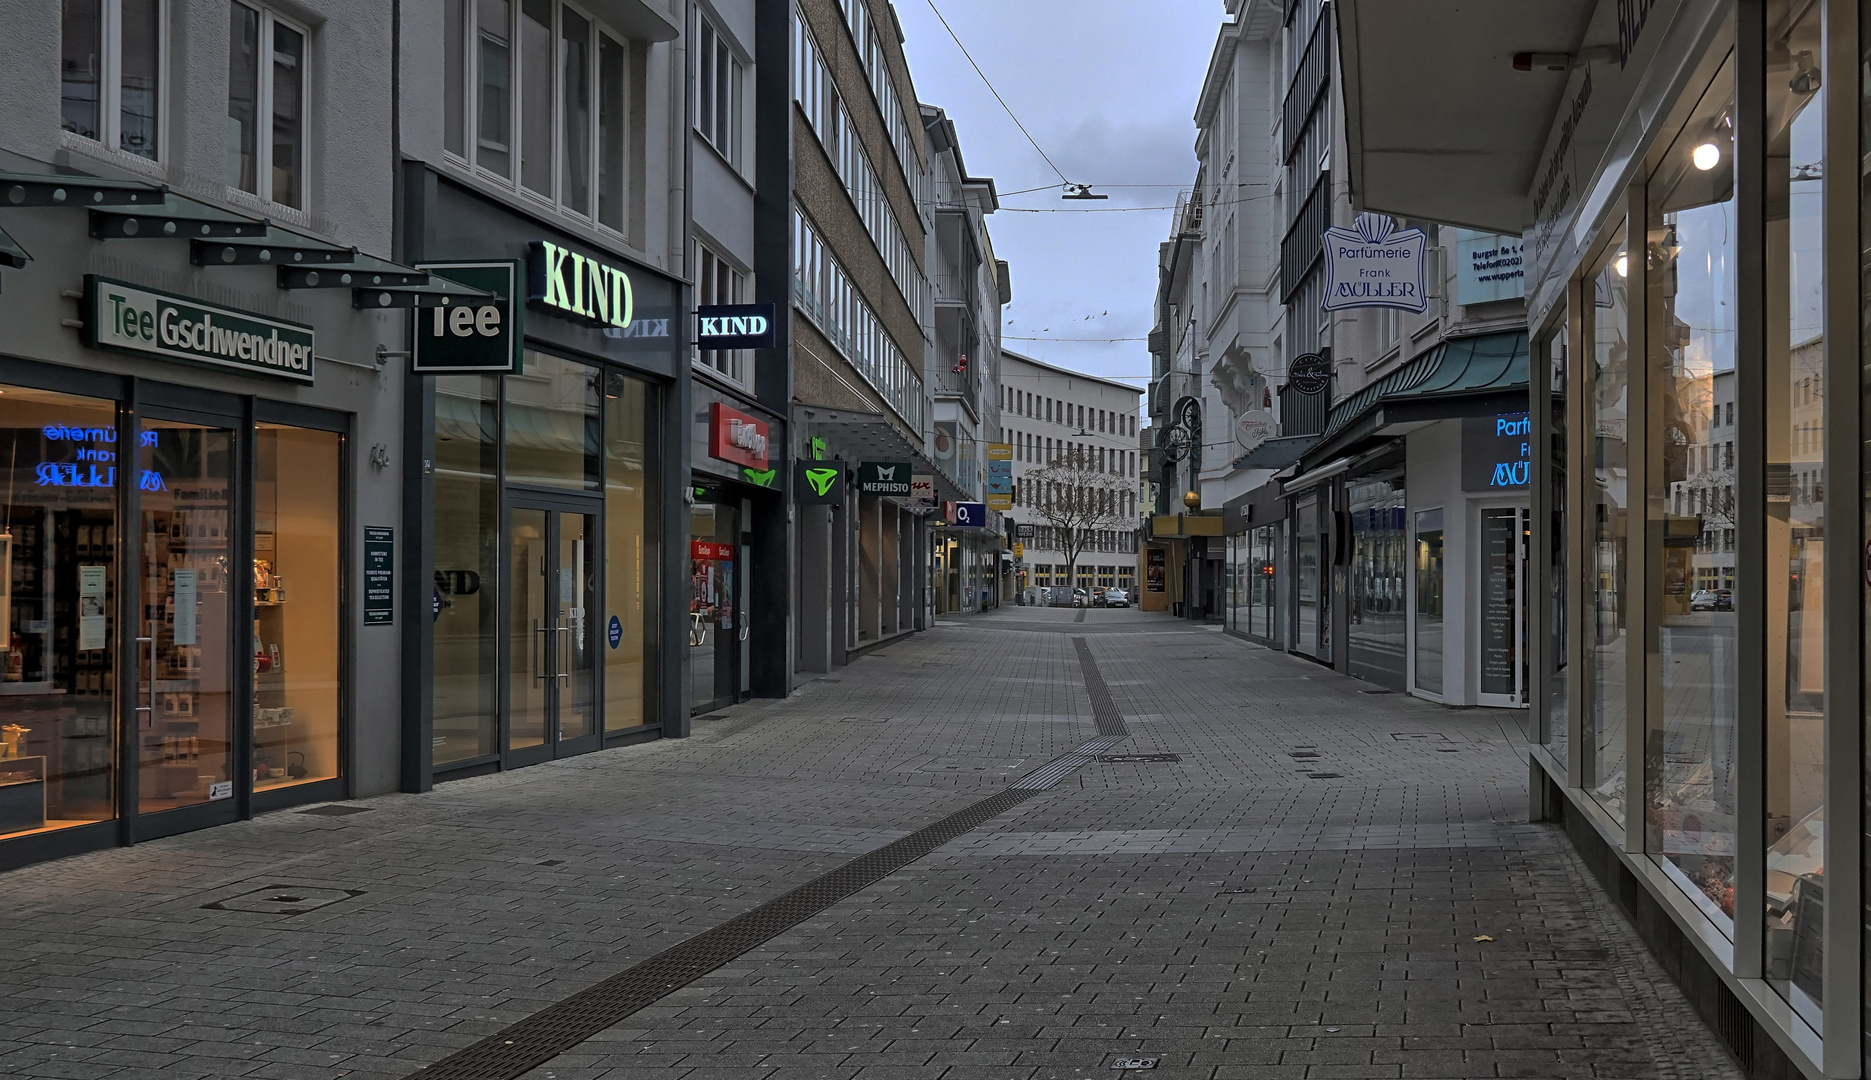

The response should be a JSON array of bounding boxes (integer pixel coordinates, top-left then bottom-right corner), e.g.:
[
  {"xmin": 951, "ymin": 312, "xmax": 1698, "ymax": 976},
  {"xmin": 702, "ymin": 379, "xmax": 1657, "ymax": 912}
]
[{"xmin": 1645, "ymin": 60, "xmax": 1749, "ymax": 927}]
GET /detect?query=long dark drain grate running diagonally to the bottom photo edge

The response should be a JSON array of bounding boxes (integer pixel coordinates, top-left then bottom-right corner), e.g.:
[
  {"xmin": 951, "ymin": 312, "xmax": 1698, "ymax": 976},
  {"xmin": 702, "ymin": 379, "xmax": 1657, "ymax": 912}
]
[{"xmin": 410, "ymin": 788, "xmax": 1035, "ymax": 1080}]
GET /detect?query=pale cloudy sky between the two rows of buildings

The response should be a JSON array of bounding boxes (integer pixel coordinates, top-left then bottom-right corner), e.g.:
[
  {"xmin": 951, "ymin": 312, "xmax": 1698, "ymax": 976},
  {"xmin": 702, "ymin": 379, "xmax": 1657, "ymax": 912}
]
[{"xmin": 894, "ymin": 0, "xmax": 1224, "ymax": 400}]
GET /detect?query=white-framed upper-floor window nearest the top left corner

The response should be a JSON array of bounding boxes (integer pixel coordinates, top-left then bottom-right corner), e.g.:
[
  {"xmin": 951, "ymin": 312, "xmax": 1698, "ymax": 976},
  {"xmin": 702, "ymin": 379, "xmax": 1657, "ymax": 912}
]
[{"xmin": 60, "ymin": 0, "xmax": 163, "ymax": 161}]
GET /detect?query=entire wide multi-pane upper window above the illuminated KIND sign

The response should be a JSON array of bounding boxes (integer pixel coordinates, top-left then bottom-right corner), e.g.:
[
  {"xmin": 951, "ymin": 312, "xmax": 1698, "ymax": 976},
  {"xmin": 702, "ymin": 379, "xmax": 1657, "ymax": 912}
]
[{"xmin": 442, "ymin": 0, "xmax": 645, "ymax": 240}]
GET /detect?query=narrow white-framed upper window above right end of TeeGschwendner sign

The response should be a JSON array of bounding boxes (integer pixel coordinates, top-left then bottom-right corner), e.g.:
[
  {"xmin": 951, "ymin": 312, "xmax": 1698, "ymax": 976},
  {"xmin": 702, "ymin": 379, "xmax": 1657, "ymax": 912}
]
[{"xmin": 226, "ymin": 0, "xmax": 309, "ymax": 210}]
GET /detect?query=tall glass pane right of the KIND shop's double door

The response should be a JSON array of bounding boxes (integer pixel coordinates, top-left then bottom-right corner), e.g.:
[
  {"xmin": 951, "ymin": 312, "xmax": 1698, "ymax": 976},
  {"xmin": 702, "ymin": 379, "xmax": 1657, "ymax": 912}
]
[{"xmin": 599, "ymin": 372, "xmax": 657, "ymax": 732}]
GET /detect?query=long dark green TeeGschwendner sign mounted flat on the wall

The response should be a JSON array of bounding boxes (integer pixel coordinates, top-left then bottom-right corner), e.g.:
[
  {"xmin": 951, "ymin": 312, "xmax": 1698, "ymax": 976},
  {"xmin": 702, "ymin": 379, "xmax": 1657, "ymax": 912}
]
[{"xmin": 84, "ymin": 273, "xmax": 312, "ymax": 382}]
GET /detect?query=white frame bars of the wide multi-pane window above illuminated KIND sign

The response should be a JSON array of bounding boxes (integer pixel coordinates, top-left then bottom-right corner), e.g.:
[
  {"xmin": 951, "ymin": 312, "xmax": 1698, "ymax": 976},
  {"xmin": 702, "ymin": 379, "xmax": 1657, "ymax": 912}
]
[{"xmin": 442, "ymin": 0, "xmax": 642, "ymax": 237}]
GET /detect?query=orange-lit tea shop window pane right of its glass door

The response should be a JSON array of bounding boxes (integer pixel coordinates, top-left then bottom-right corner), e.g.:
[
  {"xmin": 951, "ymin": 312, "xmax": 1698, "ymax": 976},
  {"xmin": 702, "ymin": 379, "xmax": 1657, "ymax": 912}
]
[{"xmin": 253, "ymin": 423, "xmax": 342, "ymax": 790}]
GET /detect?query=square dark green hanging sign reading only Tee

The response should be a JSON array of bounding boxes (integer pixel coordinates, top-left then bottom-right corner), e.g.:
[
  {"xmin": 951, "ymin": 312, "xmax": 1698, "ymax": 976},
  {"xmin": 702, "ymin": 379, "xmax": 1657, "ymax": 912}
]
[{"xmin": 410, "ymin": 260, "xmax": 526, "ymax": 374}]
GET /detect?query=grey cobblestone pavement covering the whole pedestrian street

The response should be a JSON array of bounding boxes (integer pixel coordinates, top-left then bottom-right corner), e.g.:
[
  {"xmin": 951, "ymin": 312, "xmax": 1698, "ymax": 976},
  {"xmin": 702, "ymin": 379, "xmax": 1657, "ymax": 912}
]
[{"xmin": 0, "ymin": 608, "xmax": 1736, "ymax": 1080}]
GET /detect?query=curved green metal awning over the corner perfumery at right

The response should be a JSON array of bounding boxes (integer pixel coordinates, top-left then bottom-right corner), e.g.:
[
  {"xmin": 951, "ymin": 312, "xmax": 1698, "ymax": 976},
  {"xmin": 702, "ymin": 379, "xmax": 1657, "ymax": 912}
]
[{"xmin": 1289, "ymin": 329, "xmax": 1527, "ymax": 467}]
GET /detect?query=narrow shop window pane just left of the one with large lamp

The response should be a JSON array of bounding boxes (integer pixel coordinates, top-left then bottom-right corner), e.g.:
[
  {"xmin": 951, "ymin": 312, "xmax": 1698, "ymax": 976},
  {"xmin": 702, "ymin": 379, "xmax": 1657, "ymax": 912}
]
[{"xmin": 1583, "ymin": 229, "xmax": 1630, "ymax": 820}]
